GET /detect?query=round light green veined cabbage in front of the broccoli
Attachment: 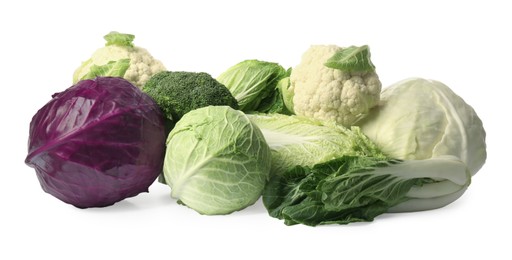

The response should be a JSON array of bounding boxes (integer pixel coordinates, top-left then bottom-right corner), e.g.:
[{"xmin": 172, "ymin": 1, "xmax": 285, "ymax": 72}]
[{"xmin": 164, "ymin": 106, "xmax": 271, "ymax": 215}]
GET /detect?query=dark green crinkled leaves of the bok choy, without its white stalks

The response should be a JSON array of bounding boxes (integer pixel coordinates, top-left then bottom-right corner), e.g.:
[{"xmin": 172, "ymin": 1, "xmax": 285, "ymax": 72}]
[{"xmin": 263, "ymin": 156, "xmax": 429, "ymax": 226}]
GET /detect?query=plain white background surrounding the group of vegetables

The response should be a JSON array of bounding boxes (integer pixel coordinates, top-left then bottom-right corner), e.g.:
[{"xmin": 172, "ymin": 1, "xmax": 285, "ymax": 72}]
[{"xmin": 0, "ymin": 0, "xmax": 512, "ymax": 260}]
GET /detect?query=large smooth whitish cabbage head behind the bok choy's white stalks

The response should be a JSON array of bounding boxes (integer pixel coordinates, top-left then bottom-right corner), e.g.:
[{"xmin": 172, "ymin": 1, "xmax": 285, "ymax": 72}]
[{"xmin": 359, "ymin": 78, "xmax": 487, "ymax": 175}]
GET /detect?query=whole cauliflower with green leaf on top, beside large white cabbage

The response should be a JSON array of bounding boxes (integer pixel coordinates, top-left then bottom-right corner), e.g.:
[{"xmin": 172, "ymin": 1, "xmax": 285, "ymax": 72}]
[{"xmin": 289, "ymin": 45, "xmax": 382, "ymax": 126}]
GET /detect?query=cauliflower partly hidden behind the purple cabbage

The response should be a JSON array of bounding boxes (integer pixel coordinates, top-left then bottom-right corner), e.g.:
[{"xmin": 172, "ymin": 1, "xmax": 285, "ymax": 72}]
[{"xmin": 73, "ymin": 32, "xmax": 166, "ymax": 88}]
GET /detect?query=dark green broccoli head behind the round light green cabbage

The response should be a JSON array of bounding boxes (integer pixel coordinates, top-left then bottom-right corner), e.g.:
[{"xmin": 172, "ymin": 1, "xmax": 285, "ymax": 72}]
[{"xmin": 142, "ymin": 71, "xmax": 238, "ymax": 122}]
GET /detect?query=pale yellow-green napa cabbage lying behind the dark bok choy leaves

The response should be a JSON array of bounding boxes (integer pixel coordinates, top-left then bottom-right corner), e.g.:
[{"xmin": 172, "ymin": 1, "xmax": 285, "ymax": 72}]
[{"xmin": 247, "ymin": 114, "xmax": 385, "ymax": 174}]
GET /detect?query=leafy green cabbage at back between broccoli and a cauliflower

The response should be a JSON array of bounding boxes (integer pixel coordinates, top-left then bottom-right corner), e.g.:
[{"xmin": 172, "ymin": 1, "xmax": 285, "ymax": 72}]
[{"xmin": 217, "ymin": 60, "xmax": 289, "ymax": 112}]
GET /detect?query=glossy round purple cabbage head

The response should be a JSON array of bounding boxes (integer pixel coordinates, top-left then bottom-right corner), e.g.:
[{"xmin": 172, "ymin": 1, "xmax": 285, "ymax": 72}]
[{"xmin": 25, "ymin": 77, "xmax": 165, "ymax": 208}]
